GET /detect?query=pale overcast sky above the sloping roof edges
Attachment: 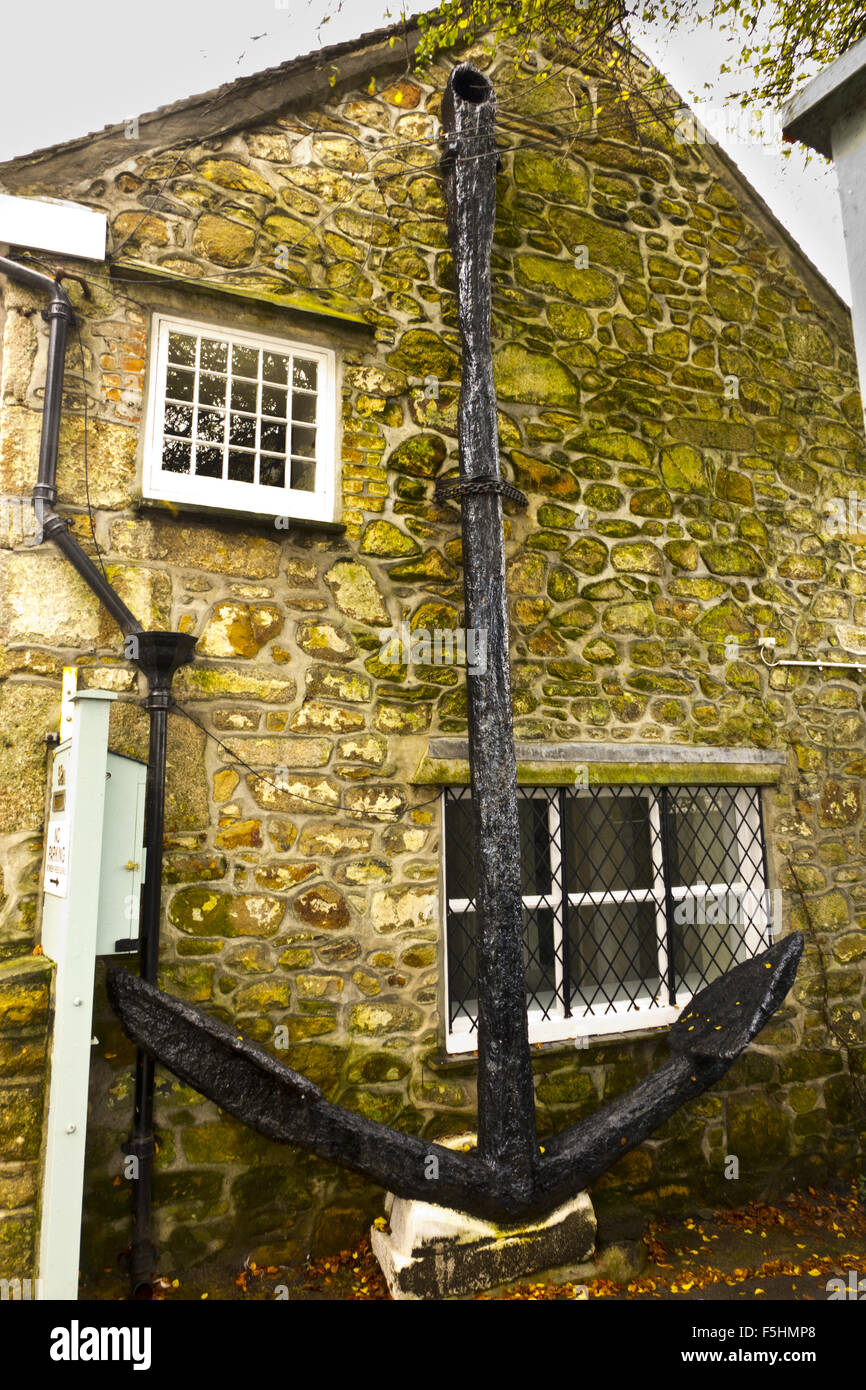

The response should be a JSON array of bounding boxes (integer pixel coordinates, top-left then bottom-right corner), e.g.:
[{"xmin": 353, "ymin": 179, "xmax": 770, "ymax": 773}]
[{"xmin": 0, "ymin": 0, "xmax": 849, "ymax": 300}]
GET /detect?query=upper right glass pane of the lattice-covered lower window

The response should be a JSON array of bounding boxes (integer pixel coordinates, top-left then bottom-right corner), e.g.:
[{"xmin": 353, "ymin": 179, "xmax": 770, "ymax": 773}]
[{"xmin": 669, "ymin": 787, "xmax": 740, "ymax": 887}]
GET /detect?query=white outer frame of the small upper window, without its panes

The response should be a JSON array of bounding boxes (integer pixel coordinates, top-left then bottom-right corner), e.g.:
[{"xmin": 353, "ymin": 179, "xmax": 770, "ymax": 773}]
[{"xmin": 142, "ymin": 314, "xmax": 338, "ymax": 521}]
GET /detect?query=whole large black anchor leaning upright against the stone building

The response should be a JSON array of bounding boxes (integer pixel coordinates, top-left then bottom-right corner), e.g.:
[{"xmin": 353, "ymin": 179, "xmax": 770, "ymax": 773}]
[{"xmin": 108, "ymin": 64, "xmax": 803, "ymax": 1223}]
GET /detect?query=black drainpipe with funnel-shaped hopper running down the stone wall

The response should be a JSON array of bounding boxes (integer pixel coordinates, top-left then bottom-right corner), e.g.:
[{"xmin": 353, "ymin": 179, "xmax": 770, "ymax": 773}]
[{"xmin": 0, "ymin": 256, "xmax": 196, "ymax": 1298}]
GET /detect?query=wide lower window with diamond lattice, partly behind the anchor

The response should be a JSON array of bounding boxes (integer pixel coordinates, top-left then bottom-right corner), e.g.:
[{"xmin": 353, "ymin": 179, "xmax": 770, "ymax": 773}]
[{"xmin": 445, "ymin": 787, "xmax": 774, "ymax": 1052}]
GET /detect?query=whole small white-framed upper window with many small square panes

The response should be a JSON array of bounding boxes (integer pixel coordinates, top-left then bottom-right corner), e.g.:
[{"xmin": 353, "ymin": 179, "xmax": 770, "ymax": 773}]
[{"xmin": 143, "ymin": 314, "xmax": 336, "ymax": 521}]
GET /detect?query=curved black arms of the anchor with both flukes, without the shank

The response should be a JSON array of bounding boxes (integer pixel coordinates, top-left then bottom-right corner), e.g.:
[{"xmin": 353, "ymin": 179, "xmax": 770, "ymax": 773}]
[{"xmin": 108, "ymin": 933, "xmax": 803, "ymax": 1222}]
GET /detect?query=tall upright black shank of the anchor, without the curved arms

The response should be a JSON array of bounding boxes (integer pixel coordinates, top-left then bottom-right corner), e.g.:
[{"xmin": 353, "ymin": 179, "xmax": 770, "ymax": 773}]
[{"xmin": 442, "ymin": 64, "xmax": 538, "ymax": 1194}]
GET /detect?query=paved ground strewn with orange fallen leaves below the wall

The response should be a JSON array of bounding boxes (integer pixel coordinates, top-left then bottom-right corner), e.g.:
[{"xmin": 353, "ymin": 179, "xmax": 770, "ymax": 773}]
[{"xmin": 88, "ymin": 1187, "xmax": 866, "ymax": 1302}]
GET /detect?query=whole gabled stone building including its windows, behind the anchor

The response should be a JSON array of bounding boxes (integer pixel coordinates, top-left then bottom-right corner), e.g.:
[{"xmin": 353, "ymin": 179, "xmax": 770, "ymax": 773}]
[{"xmin": 0, "ymin": 16, "xmax": 866, "ymax": 1275}]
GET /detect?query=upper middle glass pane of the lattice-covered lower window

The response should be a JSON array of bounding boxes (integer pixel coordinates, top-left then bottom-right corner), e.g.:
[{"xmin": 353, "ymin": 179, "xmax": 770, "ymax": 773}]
[{"xmin": 563, "ymin": 790, "xmax": 652, "ymax": 892}]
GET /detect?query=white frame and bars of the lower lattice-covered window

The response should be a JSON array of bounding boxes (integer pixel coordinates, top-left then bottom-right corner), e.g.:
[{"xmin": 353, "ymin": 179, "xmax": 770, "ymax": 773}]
[{"xmin": 441, "ymin": 785, "xmax": 771, "ymax": 1054}]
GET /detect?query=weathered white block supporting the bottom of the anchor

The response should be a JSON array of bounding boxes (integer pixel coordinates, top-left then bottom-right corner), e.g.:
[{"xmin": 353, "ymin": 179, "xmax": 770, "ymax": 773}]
[{"xmin": 370, "ymin": 1193, "xmax": 595, "ymax": 1298}]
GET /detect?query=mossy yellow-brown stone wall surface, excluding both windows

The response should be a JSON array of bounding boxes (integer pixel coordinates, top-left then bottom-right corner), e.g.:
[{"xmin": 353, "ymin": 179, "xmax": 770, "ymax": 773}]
[{"xmin": 0, "ymin": 35, "xmax": 866, "ymax": 1270}]
